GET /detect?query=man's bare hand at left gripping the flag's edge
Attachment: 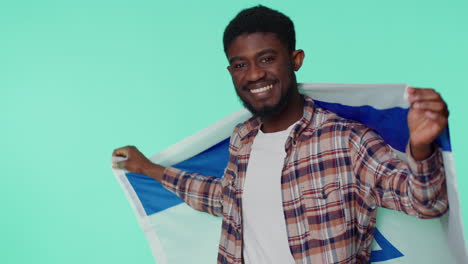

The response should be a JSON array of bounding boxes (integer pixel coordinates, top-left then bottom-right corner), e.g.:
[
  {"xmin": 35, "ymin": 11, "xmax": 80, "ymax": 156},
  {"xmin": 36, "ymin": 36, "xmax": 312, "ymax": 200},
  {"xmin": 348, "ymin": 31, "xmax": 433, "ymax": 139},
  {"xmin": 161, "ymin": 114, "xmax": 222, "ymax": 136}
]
[{"xmin": 112, "ymin": 146, "xmax": 164, "ymax": 181}]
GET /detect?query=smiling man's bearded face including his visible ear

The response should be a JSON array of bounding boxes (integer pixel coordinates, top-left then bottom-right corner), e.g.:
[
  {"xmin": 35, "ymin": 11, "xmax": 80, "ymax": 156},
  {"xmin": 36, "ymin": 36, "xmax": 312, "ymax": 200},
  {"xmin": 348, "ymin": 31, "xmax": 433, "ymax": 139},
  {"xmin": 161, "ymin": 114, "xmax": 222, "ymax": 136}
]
[{"xmin": 227, "ymin": 33, "xmax": 303, "ymax": 117}]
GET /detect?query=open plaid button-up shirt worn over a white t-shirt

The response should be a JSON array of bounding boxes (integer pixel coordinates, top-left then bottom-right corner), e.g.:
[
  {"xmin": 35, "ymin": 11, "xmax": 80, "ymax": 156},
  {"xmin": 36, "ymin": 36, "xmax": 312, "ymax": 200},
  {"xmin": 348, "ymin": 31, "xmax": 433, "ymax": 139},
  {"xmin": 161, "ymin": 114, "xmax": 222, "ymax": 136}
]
[{"xmin": 163, "ymin": 97, "xmax": 448, "ymax": 264}]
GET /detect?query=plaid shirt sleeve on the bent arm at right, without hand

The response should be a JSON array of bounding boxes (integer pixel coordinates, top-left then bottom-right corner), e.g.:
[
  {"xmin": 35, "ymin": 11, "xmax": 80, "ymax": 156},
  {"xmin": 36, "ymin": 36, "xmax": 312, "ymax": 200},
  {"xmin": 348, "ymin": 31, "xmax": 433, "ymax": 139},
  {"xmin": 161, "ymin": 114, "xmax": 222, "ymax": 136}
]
[{"xmin": 350, "ymin": 127, "xmax": 448, "ymax": 218}]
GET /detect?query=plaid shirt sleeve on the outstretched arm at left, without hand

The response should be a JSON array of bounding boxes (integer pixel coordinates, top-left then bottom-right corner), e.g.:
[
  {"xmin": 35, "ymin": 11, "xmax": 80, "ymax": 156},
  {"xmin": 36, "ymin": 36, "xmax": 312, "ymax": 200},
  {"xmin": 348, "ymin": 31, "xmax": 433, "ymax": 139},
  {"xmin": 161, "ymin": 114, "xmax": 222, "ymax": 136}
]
[{"xmin": 162, "ymin": 167, "xmax": 223, "ymax": 216}]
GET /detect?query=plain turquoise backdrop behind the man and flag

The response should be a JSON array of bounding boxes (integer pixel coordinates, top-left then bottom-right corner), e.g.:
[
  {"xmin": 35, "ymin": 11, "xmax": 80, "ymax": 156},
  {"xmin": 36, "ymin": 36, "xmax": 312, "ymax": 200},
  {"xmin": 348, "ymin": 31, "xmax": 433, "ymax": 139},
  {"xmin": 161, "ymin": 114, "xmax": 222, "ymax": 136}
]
[{"xmin": 0, "ymin": 0, "xmax": 468, "ymax": 264}]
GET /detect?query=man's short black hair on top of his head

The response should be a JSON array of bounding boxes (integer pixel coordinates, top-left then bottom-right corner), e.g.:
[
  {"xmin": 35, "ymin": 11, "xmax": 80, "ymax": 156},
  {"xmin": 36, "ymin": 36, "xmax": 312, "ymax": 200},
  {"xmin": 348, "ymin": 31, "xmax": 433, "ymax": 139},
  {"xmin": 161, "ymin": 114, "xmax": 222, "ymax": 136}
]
[{"xmin": 223, "ymin": 5, "xmax": 296, "ymax": 53}]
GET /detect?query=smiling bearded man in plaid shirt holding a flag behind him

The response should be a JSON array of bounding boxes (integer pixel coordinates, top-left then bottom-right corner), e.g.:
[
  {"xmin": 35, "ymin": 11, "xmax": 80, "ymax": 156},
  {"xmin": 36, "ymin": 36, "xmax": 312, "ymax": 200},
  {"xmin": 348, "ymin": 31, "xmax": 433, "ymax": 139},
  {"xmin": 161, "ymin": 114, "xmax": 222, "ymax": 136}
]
[{"xmin": 113, "ymin": 6, "xmax": 448, "ymax": 264}]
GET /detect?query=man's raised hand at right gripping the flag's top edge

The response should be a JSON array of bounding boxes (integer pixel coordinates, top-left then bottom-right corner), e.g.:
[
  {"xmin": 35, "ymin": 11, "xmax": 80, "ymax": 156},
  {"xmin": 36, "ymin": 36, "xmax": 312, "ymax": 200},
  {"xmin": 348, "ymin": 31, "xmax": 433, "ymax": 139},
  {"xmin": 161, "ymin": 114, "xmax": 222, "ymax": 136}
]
[{"xmin": 408, "ymin": 87, "xmax": 448, "ymax": 160}]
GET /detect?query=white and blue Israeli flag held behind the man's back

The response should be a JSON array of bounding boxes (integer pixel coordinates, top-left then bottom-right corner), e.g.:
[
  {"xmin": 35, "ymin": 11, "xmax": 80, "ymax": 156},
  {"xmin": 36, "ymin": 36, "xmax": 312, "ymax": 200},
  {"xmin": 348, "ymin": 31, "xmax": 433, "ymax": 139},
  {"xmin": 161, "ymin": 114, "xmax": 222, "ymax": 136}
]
[{"xmin": 114, "ymin": 83, "xmax": 468, "ymax": 264}]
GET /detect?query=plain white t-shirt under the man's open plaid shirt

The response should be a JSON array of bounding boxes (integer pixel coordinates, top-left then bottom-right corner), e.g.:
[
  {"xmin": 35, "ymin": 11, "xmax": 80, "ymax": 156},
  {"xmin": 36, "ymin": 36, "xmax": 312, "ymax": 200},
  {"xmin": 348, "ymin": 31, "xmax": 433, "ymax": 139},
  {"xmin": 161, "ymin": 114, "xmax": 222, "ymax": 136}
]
[{"xmin": 242, "ymin": 124, "xmax": 295, "ymax": 264}]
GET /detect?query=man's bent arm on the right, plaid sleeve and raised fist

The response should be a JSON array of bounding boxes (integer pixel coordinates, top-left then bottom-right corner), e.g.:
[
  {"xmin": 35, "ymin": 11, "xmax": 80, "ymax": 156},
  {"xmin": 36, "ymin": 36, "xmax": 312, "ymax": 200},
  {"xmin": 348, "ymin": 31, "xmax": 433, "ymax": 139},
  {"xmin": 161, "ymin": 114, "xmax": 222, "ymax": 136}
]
[{"xmin": 351, "ymin": 88, "xmax": 448, "ymax": 218}]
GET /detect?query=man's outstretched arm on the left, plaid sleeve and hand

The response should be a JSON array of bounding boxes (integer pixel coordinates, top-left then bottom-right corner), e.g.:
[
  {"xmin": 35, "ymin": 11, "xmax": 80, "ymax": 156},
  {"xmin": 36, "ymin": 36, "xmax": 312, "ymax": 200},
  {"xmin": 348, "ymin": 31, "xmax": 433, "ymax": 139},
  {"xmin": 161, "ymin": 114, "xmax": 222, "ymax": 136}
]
[{"xmin": 112, "ymin": 146, "xmax": 222, "ymax": 216}]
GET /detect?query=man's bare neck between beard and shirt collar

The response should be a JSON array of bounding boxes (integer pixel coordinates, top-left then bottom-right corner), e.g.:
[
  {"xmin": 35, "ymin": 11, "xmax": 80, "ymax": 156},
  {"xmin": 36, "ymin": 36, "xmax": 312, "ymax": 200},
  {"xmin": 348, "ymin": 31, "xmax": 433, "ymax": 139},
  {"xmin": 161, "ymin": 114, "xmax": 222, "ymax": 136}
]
[{"xmin": 261, "ymin": 93, "xmax": 304, "ymax": 133}]
